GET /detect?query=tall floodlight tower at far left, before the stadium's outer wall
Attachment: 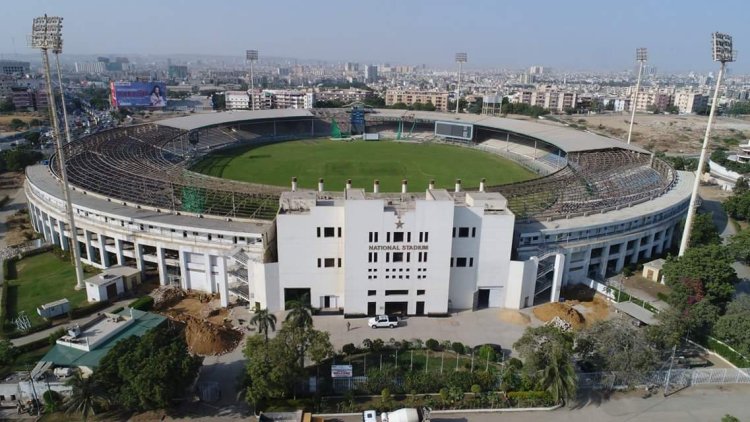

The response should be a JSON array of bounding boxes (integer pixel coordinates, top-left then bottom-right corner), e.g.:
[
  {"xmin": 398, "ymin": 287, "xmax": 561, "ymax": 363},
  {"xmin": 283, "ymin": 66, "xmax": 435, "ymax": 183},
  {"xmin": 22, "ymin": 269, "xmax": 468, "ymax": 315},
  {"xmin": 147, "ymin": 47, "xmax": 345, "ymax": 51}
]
[{"xmin": 31, "ymin": 15, "xmax": 85, "ymax": 289}]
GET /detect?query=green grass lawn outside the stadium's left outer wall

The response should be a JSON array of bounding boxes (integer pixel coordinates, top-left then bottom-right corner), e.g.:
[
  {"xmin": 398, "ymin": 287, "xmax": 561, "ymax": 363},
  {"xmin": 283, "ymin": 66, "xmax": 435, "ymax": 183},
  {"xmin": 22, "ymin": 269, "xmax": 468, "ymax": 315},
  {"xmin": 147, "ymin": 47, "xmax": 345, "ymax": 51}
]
[{"xmin": 6, "ymin": 252, "xmax": 95, "ymax": 325}]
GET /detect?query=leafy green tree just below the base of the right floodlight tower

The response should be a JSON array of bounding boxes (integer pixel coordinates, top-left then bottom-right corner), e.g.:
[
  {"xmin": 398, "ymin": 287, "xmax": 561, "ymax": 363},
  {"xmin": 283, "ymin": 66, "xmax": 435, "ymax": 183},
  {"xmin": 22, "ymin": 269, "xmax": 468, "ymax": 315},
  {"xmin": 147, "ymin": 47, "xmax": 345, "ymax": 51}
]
[{"xmin": 664, "ymin": 245, "xmax": 737, "ymax": 308}]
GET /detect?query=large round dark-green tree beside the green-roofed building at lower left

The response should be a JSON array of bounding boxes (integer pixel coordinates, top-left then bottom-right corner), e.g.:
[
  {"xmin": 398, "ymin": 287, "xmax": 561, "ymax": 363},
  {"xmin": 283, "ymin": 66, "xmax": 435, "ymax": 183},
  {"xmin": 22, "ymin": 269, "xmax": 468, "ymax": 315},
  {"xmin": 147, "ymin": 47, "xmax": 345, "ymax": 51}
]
[{"xmin": 96, "ymin": 326, "xmax": 203, "ymax": 411}]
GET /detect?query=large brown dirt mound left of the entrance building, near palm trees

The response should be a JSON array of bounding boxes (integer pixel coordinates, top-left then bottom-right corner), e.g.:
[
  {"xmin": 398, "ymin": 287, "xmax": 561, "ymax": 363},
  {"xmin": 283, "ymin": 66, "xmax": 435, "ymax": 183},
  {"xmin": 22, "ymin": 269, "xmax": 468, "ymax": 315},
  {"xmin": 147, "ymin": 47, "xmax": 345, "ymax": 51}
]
[{"xmin": 184, "ymin": 315, "xmax": 242, "ymax": 356}]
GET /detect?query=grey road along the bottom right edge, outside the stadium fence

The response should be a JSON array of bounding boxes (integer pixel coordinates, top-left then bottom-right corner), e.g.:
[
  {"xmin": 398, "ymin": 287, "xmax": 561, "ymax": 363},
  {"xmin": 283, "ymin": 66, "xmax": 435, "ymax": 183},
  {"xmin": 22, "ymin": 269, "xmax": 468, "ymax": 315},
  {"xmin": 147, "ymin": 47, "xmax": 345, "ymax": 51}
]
[{"xmin": 332, "ymin": 385, "xmax": 750, "ymax": 422}]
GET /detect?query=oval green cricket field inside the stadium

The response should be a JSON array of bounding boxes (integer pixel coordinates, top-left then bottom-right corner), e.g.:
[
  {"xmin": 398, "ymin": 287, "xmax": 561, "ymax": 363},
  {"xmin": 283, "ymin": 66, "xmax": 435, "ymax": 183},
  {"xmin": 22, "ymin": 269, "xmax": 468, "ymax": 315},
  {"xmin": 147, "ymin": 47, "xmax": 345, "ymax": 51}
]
[{"xmin": 192, "ymin": 139, "xmax": 536, "ymax": 192}]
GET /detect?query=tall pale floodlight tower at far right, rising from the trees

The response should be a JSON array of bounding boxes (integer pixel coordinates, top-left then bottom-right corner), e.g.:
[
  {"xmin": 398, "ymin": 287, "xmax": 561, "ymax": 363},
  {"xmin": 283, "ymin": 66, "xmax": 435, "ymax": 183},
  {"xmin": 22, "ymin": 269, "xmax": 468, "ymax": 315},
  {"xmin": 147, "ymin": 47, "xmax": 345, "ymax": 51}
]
[{"xmin": 678, "ymin": 32, "xmax": 735, "ymax": 256}]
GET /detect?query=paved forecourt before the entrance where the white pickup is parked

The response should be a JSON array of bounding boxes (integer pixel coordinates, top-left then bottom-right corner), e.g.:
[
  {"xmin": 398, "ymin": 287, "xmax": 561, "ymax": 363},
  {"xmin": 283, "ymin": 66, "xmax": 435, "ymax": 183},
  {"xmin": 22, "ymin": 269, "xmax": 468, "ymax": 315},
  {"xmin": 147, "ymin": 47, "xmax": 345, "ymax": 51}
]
[{"xmin": 313, "ymin": 309, "xmax": 539, "ymax": 353}]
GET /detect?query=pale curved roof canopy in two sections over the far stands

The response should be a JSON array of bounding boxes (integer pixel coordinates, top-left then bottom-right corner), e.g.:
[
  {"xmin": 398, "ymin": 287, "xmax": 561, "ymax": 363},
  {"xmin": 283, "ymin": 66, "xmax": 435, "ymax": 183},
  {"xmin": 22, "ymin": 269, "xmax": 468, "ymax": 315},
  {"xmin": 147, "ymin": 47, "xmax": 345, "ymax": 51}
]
[{"xmin": 158, "ymin": 109, "xmax": 648, "ymax": 153}]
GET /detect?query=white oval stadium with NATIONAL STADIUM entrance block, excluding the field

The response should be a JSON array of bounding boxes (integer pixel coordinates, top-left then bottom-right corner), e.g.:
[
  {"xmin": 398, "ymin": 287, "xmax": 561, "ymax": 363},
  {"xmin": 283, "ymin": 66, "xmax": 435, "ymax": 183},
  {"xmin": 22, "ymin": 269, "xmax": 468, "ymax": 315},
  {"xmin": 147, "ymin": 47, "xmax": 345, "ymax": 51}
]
[{"xmin": 25, "ymin": 109, "xmax": 695, "ymax": 316}]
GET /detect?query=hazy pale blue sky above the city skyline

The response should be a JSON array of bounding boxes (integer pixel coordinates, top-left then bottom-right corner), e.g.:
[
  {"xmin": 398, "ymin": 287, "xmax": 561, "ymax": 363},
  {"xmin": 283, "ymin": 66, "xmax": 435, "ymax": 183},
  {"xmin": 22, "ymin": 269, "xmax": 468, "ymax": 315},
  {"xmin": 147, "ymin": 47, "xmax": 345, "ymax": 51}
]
[{"xmin": 0, "ymin": 0, "xmax": 750, "ymax": 73}]
